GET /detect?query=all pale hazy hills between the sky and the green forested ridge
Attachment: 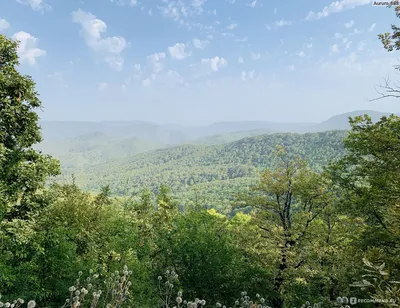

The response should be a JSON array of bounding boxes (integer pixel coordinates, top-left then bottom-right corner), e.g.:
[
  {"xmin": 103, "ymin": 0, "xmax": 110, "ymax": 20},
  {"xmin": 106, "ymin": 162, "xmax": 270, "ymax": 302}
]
[{"xmin": 36, "ymin": 110, "xmax": 396, "ymax": 170}]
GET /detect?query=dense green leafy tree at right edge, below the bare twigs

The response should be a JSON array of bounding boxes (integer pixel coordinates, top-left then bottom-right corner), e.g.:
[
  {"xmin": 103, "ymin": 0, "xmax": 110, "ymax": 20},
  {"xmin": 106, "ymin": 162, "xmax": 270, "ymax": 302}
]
[{"xmin": 328, "ymin": 115, "xmax": 400, "ymax": 275}]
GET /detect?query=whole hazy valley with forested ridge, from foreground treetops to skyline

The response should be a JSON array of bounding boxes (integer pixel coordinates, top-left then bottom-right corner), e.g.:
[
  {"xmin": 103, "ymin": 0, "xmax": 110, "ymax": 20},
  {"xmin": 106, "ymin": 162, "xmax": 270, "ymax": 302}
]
[{"xmin": 37, "ymin": 111, "xmax": 385, "ymax": 213}]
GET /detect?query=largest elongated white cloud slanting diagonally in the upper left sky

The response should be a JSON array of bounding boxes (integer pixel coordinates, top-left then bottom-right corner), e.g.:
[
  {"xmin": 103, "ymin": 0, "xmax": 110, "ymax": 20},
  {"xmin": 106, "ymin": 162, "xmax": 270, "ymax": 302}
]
[{"xmin": 72, "ymin": 9, "xmax": 128, "ymax": 70}]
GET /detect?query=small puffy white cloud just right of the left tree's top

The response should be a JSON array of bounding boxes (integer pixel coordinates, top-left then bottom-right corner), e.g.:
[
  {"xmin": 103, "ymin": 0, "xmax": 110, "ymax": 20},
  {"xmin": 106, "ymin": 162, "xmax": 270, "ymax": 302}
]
[{"xmin": 12, "ymin": 31, "xmax": 46, "ymax": 65}]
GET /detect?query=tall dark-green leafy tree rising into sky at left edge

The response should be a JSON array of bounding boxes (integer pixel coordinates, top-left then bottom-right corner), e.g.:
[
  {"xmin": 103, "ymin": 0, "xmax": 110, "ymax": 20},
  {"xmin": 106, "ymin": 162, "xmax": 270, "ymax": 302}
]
[{"xmin": 0, "ymin": 35, "xmax": 59, "ymax": 220}]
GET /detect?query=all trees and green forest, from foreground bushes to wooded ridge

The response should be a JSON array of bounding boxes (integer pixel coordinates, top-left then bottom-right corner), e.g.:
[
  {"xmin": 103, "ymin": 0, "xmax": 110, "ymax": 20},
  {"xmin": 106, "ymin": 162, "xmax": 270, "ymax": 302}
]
[{"xmin": 0, "ymin": 4, "xmax": 400, "ymax": 308}]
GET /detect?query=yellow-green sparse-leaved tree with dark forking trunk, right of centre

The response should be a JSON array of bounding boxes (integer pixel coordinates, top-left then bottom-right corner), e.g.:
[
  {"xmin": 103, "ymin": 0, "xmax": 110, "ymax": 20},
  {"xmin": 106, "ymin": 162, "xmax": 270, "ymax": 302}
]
[{"xmin": 238, "ymin": 148, "xmax": 332, "ymax": 308}]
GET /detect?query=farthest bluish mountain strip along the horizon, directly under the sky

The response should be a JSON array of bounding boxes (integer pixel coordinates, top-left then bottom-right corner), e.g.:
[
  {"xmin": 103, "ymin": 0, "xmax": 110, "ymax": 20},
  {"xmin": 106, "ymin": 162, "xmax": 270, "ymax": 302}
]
[{"xmin": 40, "ymin": 110, "xmax": 389, "ymax": 144}]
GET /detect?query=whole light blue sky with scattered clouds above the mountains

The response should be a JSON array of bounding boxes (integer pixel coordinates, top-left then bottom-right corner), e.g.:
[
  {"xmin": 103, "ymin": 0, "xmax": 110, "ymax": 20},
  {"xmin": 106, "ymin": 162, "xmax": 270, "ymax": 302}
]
[{"xmin": 0, "ymin": 0, "xmax": 400, "ymax": 125}]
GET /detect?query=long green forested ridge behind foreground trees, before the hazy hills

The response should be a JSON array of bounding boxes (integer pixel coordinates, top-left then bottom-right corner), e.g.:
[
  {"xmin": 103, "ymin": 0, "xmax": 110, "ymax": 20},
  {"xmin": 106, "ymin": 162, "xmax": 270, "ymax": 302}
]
[{"xmin": 55, "ymin": 131, "xmax": 346, "ymax": 210}]
